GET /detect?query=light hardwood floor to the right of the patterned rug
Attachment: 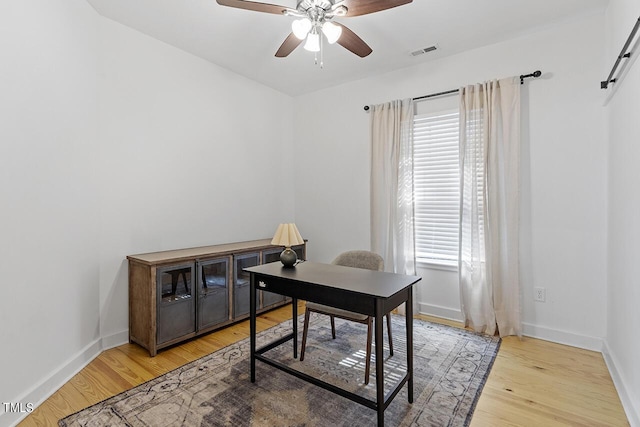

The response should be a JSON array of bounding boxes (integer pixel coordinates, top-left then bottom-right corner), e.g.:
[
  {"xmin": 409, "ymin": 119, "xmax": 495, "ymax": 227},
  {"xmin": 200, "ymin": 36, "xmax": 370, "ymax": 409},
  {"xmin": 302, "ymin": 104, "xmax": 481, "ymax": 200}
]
[{"xmin": 419, "ymin": 316, "xmax": 629, "ymax": 427}]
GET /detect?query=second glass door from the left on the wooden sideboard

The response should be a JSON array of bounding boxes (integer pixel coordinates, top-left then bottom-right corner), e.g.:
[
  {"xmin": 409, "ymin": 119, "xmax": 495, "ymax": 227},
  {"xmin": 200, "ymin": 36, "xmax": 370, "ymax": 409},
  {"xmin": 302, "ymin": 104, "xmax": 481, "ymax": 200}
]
[{"xmin": 197, "ymin": 258, "xmax": 229, "ymax": 330}]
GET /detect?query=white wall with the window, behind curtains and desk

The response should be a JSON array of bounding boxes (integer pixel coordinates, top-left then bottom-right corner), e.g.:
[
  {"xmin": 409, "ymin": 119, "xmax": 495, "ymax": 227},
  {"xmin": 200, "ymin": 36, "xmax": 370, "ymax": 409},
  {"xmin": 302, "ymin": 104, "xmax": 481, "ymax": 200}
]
[{"xmin": 295, "ymin": 14, "xmax": 606, "ymax": 350}]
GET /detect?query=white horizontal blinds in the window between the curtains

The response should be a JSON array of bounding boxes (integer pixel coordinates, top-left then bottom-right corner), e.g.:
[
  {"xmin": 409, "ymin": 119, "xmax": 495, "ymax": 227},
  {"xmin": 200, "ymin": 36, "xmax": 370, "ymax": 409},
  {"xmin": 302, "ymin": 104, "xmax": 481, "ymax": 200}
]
[{"xmin": 413, "ymin": 110, "xmax": 460, "ymax": 266}]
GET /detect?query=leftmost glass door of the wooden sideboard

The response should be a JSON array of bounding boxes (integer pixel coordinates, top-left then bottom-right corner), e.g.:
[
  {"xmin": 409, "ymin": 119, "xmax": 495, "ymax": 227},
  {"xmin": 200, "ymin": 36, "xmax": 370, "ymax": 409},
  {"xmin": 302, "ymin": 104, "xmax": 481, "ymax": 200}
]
[{"xmin": 156, "ymin": 264, "xmax": 196, "ymax": 344}]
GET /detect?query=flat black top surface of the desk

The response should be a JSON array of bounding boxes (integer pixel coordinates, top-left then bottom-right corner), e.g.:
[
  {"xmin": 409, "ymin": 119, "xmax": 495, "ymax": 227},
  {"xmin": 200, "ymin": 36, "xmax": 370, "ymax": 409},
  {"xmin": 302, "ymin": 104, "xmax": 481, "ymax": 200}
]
[{"xmin": 244, "ymin": 261, "xmax": 422, "ymax": 298}]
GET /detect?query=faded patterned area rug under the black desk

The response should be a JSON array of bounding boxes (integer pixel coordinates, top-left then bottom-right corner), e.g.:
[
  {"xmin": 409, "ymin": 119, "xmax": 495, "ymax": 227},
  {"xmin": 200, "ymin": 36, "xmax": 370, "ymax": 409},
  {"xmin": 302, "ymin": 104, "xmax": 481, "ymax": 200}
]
[{"xmin": 59, "ymin": 313, "xmax": 500, "ymax": 427}]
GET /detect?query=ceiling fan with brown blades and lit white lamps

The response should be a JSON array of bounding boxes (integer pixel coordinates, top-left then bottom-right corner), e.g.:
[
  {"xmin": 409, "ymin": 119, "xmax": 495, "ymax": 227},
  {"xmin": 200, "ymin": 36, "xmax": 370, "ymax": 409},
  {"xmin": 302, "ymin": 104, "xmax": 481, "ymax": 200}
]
[{"xmin": 216, "ymin": 0, "xmax": 413, "ymax": 61}]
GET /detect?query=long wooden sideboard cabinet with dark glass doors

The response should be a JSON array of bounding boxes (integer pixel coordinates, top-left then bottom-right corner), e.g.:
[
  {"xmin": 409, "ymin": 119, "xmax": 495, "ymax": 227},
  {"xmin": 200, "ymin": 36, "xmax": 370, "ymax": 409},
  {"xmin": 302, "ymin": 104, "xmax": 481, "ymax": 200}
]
[{"xmin": 127, "ymin": 239, "xmax": 306, "ymax": 356}]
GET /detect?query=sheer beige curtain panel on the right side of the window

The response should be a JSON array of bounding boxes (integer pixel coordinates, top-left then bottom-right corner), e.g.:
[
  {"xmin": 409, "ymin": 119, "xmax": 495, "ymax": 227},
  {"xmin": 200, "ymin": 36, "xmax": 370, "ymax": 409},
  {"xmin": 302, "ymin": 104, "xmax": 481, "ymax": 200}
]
[{"xmin": 458, "ymin": 77, "xmax": 521, "ymax": 336}]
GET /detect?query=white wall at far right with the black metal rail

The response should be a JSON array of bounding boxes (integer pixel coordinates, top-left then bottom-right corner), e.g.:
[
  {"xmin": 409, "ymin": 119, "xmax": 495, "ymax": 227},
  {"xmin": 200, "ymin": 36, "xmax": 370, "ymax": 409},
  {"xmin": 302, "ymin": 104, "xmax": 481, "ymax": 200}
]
[{"xmin": 601, "ymin": 0, "xmax": 640, "ymax": 426}]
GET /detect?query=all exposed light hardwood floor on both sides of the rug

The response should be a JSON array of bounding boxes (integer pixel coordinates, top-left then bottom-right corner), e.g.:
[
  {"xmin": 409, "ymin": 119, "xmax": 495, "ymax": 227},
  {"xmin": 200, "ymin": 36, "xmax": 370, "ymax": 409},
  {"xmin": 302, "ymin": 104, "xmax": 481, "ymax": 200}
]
[{"xmin": 19, "ymin": 304, "xmax": 629, "ymax": 427}]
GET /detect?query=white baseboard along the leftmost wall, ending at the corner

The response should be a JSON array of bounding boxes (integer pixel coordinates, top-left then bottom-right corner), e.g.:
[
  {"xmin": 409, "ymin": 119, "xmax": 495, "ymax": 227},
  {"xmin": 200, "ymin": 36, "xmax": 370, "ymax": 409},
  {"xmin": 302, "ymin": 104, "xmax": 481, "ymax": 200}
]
[{"xmin": 0, "ymin": 339, "xmax": 102, "ymax": 426}]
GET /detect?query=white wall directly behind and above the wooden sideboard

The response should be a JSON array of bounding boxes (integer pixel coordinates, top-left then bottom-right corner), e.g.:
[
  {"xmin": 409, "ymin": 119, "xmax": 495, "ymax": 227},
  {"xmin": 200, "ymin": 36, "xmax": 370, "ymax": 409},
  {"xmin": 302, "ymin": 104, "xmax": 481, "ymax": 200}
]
[{"xmin": 99, "ymin": 19, "xmax": 293, "ymax": 344}]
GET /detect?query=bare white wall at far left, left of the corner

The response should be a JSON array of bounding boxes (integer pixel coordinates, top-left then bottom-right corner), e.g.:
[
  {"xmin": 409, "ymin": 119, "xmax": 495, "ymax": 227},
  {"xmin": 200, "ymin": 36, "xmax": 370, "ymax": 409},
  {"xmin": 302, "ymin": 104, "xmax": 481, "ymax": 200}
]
[{"xmin": 0, "ymin": 0, "xmax": 99, "ymax": 425}]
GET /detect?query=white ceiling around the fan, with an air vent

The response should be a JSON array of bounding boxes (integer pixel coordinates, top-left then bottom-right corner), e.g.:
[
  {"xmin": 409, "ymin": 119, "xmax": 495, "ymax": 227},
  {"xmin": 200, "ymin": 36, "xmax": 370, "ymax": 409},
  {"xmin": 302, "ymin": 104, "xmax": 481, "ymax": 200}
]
[{"xmin": 87, "ymin": 0, "xmax": 608, "ymax": 95}]
